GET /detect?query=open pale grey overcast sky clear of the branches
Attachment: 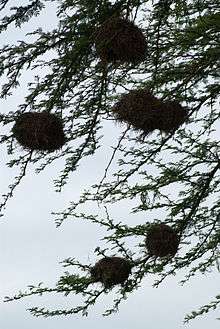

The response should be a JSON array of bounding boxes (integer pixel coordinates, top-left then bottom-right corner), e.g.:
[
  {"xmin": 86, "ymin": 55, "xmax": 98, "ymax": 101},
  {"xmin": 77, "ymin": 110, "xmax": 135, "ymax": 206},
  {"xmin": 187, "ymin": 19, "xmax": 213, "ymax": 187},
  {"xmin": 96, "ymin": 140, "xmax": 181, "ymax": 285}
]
[{"xmin": 0, "ymin": 1, "xmax": 219, "ymax": 329}]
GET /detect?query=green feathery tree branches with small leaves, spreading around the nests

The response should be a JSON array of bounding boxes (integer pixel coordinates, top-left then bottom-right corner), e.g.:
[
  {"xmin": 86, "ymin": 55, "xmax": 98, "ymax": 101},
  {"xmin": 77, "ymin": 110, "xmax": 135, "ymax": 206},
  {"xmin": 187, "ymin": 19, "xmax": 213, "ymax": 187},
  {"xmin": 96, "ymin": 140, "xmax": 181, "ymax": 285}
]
[{"xmin": 0, "ymin": 0, "xmax": 220, "ymax": 321}]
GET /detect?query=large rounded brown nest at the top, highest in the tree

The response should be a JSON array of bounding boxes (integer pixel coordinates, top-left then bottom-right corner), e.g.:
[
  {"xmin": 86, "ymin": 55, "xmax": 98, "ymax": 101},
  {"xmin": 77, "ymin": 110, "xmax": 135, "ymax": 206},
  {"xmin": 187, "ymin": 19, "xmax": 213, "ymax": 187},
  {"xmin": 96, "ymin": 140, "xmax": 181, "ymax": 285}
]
[{"xmin": 94, "ymin": 17, "xmax": 147, "ymax": 63}]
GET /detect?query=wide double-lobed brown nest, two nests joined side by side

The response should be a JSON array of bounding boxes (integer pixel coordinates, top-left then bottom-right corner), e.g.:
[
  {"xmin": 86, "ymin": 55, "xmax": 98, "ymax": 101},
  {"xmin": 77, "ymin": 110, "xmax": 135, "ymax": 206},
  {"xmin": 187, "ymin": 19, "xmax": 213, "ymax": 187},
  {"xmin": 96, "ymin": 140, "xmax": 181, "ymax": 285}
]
[{"xmin": 112, "ymin": 89, "xmax": 188, "ymax": 135}]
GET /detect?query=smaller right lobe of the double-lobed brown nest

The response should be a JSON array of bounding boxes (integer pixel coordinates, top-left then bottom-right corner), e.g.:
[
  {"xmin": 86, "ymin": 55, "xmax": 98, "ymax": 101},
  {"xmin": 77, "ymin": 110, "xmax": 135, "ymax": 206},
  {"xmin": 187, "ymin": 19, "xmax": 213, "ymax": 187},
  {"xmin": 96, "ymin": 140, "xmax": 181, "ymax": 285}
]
[{"xmin": 158, "ymin": 101, "xmax": 188, "ymax": 133}]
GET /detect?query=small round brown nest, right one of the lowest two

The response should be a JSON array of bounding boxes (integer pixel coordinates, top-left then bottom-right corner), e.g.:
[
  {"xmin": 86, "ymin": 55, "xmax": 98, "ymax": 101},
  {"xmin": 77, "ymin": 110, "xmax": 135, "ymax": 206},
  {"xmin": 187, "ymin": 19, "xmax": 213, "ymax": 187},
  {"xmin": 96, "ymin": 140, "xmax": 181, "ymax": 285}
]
[{"xmin": 145, "ymin": 224, "xmax": 179, "ymax": 257}]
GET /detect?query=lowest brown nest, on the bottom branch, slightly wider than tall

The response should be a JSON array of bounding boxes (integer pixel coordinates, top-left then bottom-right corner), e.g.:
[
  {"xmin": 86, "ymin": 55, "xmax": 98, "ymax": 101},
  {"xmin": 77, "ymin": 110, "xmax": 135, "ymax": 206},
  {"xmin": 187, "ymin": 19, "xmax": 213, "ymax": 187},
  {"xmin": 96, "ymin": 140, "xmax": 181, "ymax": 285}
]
[{"xmin": 91, "ymin": 257, "xmax": 131, "ymax": 288}]
